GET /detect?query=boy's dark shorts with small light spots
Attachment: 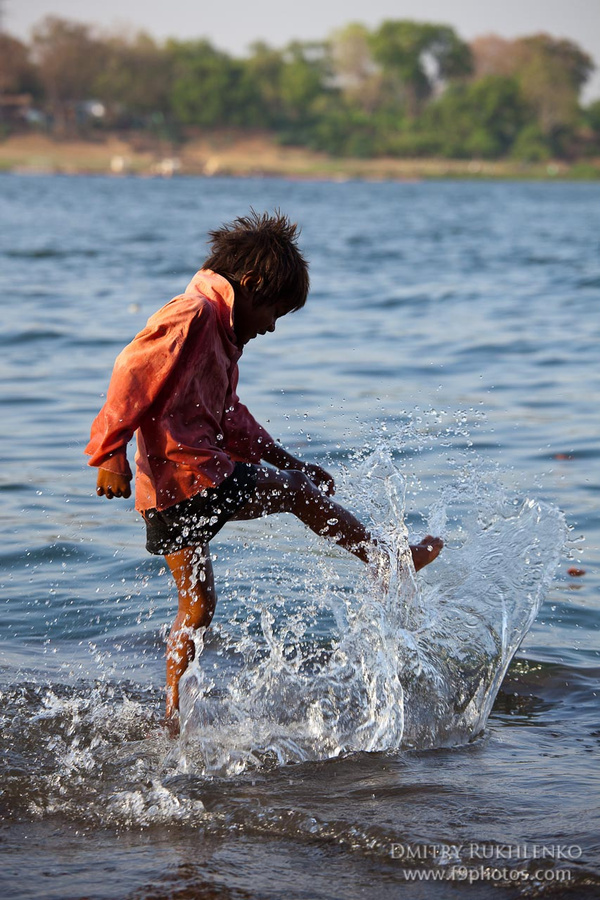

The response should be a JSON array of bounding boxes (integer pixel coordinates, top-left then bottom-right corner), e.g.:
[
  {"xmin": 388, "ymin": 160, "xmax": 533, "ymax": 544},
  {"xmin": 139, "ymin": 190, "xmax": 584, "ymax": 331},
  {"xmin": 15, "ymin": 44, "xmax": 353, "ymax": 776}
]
[{"xmin": 142, "ymin": 463, "xmax": 258, "ymax": 556}]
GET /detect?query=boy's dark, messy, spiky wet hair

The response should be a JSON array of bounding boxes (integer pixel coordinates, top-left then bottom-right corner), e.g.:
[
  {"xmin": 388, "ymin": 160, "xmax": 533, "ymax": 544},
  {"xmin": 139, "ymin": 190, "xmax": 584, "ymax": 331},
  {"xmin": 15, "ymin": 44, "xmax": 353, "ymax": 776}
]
[{"xmin": 203, "ymin": 209, "xmax": 309, "ymax": 312}]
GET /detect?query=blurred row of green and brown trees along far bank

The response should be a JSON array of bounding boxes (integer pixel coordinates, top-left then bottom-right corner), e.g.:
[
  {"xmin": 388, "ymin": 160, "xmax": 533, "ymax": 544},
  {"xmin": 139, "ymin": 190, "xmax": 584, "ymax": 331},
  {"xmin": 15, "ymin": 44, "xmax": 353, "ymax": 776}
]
[{"xmin": 0, "ymin": 16, "xmax": 600, "ymax": 159}]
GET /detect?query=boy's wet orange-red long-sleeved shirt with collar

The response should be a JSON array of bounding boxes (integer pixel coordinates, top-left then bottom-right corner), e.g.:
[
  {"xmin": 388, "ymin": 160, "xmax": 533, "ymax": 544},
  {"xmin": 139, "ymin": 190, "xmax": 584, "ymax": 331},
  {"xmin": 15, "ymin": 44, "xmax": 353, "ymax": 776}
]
[{"xmin": 85, "ymin": 269, "xmax": 274, "ymax": 510}]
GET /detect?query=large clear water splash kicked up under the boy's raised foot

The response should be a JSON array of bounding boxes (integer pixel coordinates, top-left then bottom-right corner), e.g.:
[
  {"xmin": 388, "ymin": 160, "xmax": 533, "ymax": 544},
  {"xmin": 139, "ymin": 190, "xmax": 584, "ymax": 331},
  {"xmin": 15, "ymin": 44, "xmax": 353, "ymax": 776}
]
[{"xmin": 178, "ymin": 448, "xmax": 566, "ymax": 774}]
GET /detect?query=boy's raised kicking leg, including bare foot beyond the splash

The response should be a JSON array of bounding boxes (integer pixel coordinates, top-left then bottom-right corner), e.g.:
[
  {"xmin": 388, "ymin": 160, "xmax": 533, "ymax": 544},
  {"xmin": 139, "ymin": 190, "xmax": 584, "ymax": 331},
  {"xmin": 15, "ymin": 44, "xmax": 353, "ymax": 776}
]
[{"xmin": 235, "ymin": 467, "xmax": 443, "ymax": 570}]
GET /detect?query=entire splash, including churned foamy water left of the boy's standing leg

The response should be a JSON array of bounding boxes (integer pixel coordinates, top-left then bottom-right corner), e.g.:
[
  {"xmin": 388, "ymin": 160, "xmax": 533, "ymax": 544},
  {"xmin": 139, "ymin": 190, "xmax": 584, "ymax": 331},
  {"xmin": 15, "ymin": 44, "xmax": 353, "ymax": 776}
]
[{"xmin": 0, "ymin": 428, "xmax": 566, "ymax": 830}]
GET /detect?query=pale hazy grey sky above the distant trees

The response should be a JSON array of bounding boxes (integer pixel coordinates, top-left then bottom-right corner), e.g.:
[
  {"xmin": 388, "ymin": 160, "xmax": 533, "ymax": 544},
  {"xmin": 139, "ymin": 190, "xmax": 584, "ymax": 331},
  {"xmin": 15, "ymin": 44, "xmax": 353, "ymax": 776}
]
[{"xmin": 5, "ymin": 0, "xmax": 600, "ymax": 100}]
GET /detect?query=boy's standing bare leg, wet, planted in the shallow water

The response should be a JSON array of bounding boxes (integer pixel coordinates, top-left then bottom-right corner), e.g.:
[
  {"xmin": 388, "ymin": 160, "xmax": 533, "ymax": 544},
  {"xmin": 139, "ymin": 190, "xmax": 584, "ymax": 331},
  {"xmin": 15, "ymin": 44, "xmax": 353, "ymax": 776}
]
[{"xmin": 165, "ymin": 545, "xmax": 217, "ymax": 731}]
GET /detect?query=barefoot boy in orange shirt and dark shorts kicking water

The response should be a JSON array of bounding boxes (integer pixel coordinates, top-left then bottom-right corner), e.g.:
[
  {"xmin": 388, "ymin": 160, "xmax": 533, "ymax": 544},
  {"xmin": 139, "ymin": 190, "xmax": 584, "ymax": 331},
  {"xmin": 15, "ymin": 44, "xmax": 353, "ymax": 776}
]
[{"xmin": 85, "ymin": 211, "xmax": 442, "ymax": 733}]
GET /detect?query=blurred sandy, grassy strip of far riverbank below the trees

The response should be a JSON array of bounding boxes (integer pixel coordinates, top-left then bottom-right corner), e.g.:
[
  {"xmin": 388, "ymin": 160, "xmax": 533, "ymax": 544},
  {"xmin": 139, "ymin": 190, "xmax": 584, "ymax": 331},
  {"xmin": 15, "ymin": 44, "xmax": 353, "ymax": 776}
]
[{"xmin": 0, "ymin": 132, "xmax": 600, "ymax": 181}]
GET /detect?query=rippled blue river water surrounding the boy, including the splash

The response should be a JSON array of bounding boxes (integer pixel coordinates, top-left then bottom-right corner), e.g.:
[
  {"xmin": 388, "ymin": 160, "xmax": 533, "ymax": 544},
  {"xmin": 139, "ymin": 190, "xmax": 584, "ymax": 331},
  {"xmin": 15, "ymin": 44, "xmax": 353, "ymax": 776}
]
[{"xmin": 0, "ymin": 175, "xmax": 600, "ymax": 900}]
